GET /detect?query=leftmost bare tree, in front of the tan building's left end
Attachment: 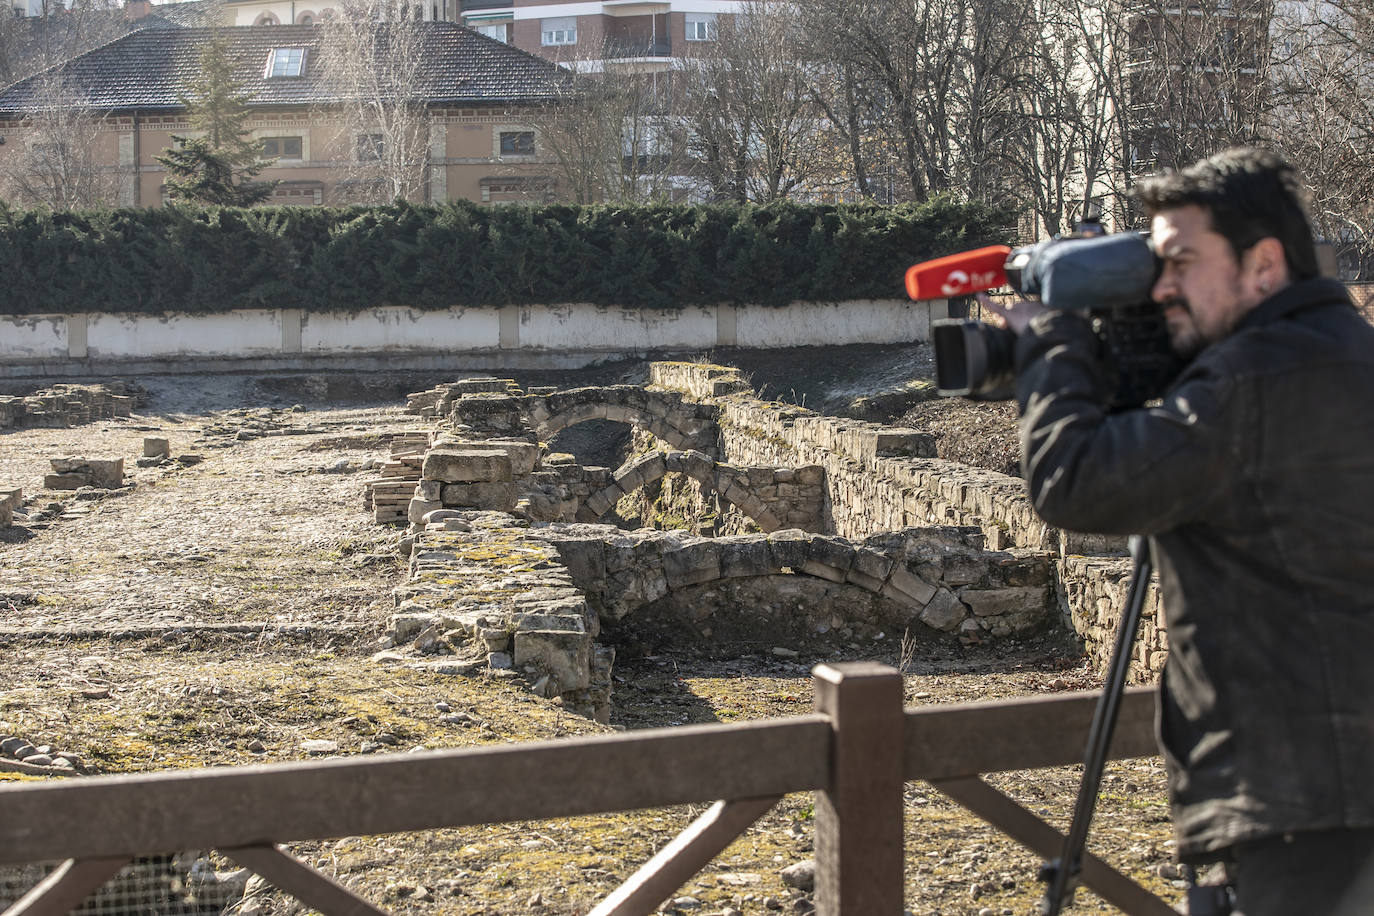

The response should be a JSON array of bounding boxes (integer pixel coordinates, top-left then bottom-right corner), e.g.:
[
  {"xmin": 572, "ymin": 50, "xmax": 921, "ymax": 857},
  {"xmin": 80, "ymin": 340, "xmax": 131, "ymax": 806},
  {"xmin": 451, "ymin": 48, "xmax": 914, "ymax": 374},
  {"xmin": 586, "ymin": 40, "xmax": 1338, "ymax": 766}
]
[{"xmin": 0, "ymin": 76, "xmax": 117, "ymax": 210}]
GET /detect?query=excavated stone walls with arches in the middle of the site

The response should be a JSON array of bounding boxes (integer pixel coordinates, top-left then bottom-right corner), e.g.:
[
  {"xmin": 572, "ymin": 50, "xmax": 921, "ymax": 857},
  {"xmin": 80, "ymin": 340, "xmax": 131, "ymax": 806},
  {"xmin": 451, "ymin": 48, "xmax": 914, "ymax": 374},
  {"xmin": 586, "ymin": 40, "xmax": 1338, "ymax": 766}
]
[{"xmin": 367, "ymin": 363, "xmax": 1165, "ymax": 721}]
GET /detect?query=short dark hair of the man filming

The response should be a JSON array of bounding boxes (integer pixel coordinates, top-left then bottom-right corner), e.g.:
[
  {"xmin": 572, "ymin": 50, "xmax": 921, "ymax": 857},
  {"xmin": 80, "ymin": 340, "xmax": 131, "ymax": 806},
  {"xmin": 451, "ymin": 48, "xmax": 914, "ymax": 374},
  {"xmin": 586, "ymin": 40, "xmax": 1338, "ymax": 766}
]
[{"xmin": 1135, "ymin": 147, "xmax": 1319, "ymax": 280}]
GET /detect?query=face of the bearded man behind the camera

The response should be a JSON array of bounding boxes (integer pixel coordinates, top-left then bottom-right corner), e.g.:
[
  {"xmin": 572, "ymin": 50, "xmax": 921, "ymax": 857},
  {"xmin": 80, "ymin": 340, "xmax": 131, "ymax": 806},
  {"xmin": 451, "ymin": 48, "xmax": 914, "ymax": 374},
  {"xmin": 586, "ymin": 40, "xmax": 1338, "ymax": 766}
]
[{"xmin": 1150, "ymin": 203, "xmax": 1268, "ymax": 357}]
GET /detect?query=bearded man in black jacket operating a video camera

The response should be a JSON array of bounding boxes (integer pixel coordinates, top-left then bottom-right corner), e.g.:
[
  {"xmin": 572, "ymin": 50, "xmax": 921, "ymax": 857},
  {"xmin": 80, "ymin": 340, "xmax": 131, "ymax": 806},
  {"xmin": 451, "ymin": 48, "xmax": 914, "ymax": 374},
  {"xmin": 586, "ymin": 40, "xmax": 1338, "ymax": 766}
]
[{"xmin": 982, "ymin": 148, "xmax": 1374, "ymax": 916}]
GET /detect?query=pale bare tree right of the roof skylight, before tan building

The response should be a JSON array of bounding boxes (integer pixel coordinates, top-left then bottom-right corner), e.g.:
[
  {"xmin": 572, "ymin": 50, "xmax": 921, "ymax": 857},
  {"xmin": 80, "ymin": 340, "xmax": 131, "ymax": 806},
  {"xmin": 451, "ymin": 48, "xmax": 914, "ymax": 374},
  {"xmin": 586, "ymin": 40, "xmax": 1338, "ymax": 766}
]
[{"xmin": 320, "ymin": 0, "xmax": 429, "ymax": 203}]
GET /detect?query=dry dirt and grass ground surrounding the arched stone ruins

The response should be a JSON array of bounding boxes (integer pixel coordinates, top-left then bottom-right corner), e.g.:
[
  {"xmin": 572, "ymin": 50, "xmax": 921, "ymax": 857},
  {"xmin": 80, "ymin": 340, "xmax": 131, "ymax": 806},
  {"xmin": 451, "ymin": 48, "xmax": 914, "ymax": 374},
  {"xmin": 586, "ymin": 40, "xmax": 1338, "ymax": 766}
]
[{"xmin": 0, "ymin": 357, "xmax": 1182, "ymax": 916}]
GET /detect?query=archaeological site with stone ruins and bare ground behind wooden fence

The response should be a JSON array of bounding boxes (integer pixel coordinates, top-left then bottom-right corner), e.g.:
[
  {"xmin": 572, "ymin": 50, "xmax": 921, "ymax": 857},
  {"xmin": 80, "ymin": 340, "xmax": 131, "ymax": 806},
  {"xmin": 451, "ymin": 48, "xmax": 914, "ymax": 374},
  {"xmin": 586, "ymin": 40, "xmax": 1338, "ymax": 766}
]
[{"xmin": 0, "ymin": 345, "xmax": 1183, "ymax": 916}]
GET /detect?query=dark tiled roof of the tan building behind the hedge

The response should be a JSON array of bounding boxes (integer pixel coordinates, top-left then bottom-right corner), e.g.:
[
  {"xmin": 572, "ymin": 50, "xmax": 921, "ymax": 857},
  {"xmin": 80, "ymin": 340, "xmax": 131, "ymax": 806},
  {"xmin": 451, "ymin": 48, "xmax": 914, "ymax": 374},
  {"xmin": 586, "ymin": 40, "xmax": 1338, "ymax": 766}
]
[{"xmin": 0, "ymin": 22, "xmax": 566, "ymax": 117}]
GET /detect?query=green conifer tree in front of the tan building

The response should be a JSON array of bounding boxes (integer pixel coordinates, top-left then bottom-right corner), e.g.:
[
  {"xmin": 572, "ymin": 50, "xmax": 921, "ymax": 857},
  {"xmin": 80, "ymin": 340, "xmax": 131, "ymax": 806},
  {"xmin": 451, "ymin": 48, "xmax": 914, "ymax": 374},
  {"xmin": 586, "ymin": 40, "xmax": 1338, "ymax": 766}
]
[{"xmin": 155, "ymin": 36, "xmax": 276, "ymax": 207}]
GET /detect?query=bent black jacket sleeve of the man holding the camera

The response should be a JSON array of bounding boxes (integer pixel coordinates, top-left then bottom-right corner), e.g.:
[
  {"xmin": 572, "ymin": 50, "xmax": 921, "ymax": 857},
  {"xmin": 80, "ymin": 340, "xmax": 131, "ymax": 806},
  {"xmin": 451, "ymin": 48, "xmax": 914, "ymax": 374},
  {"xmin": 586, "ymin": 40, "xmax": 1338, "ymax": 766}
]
[{"xmin": 1017, "ymin": 312, "xmax": 1242, "ymax": 534}]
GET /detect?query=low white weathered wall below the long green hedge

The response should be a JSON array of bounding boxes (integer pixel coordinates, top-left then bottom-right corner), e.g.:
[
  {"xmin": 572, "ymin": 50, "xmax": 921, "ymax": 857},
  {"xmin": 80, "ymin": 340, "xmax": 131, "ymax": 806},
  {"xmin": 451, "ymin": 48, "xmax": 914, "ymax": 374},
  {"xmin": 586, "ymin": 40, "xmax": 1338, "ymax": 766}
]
[{"xmin": 0, "ymin": 299, "xmax": 947, "ymax": 378}]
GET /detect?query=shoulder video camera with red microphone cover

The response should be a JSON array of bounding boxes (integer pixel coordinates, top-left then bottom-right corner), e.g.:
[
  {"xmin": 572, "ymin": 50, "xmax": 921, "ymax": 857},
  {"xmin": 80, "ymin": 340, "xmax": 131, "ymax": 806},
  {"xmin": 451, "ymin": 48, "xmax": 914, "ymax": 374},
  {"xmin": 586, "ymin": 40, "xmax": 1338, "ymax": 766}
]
[{"xmin": 907, "ymin": 227, "xmax": 1183, "ymax": 408}]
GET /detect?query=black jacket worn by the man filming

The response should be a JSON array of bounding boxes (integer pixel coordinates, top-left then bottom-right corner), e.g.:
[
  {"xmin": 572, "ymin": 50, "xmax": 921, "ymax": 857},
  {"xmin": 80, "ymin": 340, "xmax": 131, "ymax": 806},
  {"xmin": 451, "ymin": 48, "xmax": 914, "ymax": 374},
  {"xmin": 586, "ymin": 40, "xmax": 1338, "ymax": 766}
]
[{"xmin": 1017, "ymin": 279, "xmax": 1374, "ymax": 860}]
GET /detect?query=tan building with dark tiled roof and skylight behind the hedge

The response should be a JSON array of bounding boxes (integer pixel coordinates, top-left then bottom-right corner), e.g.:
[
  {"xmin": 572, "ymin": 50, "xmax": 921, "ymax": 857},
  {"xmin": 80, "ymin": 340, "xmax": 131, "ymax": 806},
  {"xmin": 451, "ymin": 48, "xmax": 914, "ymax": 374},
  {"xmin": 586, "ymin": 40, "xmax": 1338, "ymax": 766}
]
[{"xmin": 0, "ymin": 22, "xmax": 566, "ymax": 206}]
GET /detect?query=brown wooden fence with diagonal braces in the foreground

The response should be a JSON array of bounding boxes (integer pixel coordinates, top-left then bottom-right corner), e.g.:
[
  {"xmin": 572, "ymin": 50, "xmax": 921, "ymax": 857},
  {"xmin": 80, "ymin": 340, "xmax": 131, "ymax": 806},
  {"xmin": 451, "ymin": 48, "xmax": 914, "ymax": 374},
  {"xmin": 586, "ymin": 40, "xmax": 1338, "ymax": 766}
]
[{"xmin": 0, "ymin": 662, "xmax": 1173, "ymax": 916}]
